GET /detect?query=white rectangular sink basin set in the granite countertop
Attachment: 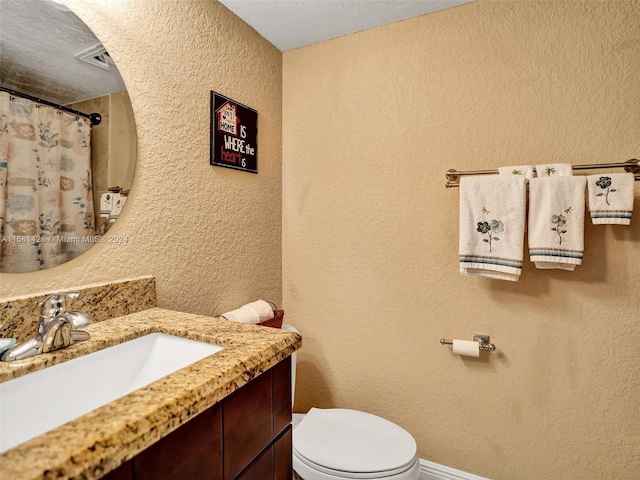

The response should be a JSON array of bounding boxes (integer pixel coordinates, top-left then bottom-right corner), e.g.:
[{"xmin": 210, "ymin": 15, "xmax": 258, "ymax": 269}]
[{"xmin": 0, "ymin": 333, "xmax": 222, "ymax": 453}]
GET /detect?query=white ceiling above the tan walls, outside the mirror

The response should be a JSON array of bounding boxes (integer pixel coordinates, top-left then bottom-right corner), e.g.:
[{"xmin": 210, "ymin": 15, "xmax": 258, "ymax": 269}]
[{"xmin": 220, "ymin": 0, "xmax": 473, "ymax": 52}]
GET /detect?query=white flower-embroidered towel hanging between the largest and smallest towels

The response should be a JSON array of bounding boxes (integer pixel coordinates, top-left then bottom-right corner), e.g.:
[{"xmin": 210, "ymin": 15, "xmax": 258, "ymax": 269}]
[{"xmin": 529, "ymin": 177, "xmax": 587, "ymax": 270}]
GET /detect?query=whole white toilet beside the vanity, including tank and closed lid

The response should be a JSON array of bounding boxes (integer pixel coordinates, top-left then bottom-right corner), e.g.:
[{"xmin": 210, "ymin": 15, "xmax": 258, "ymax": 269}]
[{"xmin": 282, "ymin": 325, "xmax": 420, "ymax": 480}]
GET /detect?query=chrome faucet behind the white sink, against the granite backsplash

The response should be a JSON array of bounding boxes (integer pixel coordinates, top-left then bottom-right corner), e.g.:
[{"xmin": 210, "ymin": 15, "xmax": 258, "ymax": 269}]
[{"xmin": 1, "ymin": 292, "xmax": 93, "ymax": 362}]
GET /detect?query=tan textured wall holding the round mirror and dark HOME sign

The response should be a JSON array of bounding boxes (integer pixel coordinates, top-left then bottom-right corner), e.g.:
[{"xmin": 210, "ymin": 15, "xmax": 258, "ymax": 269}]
[{"xmin": 0, "ymin": 0, "xmax": 282, "ymax": 314}]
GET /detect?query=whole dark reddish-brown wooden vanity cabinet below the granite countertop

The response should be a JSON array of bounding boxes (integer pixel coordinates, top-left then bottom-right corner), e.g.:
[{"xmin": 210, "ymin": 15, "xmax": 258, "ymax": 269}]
[{"xmin": 103, "ymin": 357, "xmax": 292, "ymax": 480}]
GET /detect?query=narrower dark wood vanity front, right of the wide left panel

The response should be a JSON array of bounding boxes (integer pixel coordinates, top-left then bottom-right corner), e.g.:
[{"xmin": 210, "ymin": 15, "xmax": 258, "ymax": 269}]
[{"xmin": 222, "ymin": 370, "xmax": 273, "ymax": 480}]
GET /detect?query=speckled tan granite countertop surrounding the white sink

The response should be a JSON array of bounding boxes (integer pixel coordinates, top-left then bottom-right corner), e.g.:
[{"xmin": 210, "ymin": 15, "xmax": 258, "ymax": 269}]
[{"xmin": 0, "ymin": 308, "xmax": 301, "ymax": 480}]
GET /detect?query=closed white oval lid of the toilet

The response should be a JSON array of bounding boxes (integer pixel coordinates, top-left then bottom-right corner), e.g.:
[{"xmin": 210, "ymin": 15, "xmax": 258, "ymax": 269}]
[{"xmin": 293, "ymin": 408, "xmax": 417, "ymax": 474}]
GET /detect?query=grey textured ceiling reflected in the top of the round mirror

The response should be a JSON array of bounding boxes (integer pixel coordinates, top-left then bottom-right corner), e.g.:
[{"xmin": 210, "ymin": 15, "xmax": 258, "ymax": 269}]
[{"xmin": 0, "ymin": 0, "xmax": 125, "ymax": 105}]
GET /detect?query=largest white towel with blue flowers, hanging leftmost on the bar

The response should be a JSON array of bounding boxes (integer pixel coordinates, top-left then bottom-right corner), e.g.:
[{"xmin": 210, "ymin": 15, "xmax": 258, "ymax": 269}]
[{"xmin": 459, "ymin": 175, "xmax": 527, "ymax": 282}]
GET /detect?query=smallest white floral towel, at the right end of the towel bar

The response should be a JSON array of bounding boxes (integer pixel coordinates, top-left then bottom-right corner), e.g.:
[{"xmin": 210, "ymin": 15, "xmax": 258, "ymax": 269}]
[{"xmin": 587, "ymin": 173, "xmax": 635, "ymax": 225}]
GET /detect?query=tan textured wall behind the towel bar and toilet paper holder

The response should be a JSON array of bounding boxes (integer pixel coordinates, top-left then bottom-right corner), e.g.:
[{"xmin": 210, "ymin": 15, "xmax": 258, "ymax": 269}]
[{"xmin": 283, "ymin": 1, "xmax": 640, "ymax": 480}]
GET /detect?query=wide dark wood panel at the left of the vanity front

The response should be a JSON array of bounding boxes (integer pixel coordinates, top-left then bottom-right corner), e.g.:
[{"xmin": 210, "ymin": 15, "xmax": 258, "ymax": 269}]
[{"xmin": 134, "ymin": 404, "xmax": 222, "ymax": 480}]
